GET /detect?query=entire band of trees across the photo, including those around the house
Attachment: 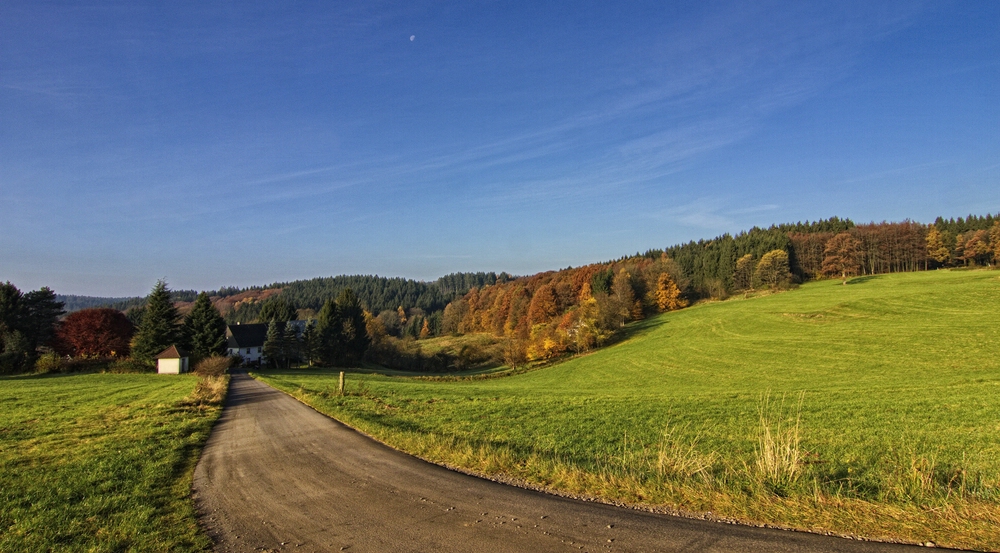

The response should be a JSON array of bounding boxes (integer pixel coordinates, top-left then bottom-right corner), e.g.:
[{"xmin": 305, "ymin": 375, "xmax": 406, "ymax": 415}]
[{"xmin": 0, "ymin": 211, "xmax": 1000, "ymax": 372}]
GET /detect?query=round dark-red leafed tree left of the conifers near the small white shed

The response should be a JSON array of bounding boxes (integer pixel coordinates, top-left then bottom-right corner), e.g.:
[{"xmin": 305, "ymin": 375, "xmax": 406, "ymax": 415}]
[{"xmin": 56, "ymin": 307, "xmax": 135, "ymax": 357}]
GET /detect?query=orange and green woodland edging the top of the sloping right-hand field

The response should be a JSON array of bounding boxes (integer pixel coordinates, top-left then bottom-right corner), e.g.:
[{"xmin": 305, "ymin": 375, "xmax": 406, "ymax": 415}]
[{"xmin": 440, "ymin": 215, "xmax": 1000, "ymax": 364}]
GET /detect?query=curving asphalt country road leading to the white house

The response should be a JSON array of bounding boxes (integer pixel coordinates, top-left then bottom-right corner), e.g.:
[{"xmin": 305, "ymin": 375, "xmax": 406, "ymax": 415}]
[{"xmin": 194, "ymin": 374, "xmax": 928, "ymax": 552}]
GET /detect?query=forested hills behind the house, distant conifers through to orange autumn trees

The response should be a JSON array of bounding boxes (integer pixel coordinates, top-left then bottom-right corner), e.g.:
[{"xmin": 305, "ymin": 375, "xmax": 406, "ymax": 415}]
[{"xmin": 31, "ymin": 214, "xmax": 1000, "ymax": 370}]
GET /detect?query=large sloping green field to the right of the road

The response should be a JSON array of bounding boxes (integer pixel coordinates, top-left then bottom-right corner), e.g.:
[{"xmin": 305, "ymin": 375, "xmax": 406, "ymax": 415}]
[{"xmin": 260, "ymin": 271, "xmax": 1000, "ymax": 550}]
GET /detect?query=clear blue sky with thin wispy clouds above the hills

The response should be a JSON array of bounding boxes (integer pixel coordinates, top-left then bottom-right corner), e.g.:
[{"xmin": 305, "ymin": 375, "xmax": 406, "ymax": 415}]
[{"xmin": 0, "ymin": 0, "xmax": 1000, "ymax": 296}]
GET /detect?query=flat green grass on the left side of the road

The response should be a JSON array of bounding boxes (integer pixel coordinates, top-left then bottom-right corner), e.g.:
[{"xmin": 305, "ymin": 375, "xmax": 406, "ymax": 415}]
[{"xmin": 0, "ymin": 374, "xmax": 228, "ymax": 552}]
